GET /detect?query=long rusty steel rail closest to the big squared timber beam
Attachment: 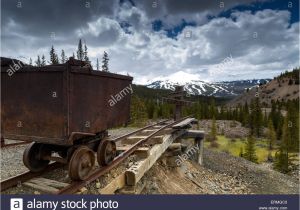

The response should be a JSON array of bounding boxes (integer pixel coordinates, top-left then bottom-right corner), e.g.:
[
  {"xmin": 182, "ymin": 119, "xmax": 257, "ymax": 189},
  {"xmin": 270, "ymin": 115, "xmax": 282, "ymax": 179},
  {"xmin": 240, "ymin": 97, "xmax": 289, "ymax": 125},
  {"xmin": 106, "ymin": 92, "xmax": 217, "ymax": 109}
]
[{"xmin": 56, "ymin": 117, "xmax": 188, "ymax": 194}]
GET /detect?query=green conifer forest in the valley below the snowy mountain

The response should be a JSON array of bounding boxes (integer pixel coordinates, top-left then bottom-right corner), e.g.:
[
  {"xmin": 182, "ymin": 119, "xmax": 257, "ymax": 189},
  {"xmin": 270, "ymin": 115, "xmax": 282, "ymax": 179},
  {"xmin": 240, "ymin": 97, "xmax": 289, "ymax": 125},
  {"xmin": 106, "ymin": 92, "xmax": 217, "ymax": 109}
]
[{"xmin": 131, "ymin": 83, "xmax": 299, "ymax": 173}]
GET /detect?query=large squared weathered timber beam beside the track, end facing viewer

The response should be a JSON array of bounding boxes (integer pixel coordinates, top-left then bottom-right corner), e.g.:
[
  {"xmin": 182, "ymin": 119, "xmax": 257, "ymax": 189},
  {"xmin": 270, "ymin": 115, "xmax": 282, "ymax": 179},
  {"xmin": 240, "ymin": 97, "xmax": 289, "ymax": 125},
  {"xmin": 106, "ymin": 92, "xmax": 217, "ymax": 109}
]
[{"xmin": 125, "ymin": 131, "xmax": 184, "ymax": 186}]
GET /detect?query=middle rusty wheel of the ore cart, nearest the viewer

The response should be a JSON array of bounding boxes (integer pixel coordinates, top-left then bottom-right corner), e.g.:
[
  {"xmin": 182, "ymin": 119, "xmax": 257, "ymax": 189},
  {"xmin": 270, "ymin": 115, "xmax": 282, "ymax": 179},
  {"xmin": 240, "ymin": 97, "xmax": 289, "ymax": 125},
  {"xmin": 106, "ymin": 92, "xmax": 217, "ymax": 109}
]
[{"xmin": 69, "ymin": 146, "xmax": 95, "ymax": 180}]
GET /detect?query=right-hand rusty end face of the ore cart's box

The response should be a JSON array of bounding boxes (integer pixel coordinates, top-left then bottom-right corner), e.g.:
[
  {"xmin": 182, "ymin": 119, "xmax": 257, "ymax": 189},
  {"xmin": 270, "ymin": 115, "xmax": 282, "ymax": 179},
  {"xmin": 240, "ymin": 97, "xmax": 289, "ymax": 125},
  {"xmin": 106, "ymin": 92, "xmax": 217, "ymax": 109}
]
[{"xmin": 69, "ymin": 70, "xmax": 130, "ymax": 143}]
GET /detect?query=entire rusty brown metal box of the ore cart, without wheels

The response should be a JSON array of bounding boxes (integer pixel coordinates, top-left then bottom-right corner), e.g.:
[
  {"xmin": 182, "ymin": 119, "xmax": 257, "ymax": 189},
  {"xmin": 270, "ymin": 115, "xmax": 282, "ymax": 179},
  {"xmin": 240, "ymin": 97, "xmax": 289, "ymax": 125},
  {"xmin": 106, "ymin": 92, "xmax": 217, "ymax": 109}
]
[{"xmin": 1, "ymin": 60, "xmax": 132, "ymax": 145}]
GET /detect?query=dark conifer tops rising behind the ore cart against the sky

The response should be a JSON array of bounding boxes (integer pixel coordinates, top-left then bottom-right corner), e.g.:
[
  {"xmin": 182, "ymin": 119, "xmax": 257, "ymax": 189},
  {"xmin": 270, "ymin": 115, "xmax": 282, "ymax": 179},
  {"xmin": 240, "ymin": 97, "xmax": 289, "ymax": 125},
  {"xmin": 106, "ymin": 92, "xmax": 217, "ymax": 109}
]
[{"xmin": 29, "ymin": 39, "xmax": 109, "ymax": 72}]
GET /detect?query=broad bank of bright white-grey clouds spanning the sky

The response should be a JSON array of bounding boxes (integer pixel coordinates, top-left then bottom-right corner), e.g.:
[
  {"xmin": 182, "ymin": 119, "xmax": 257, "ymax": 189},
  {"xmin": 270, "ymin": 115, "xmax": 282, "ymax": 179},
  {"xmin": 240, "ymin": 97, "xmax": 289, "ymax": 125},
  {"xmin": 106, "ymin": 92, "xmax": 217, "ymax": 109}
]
[{"xmin": 2, "ymin": 0, "xmax": 299, "ymax": 84}]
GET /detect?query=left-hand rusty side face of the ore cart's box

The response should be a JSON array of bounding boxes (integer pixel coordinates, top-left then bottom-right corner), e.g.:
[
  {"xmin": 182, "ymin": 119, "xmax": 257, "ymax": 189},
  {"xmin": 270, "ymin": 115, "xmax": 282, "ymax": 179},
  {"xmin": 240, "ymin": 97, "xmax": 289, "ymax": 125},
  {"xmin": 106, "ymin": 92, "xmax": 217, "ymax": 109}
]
[{"xmin": 1, "ymin": 71, "xmax": 64, "ymax": 140}]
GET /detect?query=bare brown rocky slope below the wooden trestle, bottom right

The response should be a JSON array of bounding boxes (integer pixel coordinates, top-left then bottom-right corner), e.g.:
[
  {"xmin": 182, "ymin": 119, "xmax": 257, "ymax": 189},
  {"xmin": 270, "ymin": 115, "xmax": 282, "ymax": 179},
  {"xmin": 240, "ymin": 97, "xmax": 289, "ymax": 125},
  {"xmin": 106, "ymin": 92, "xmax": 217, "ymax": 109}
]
[{"xmin": 142, "ymin": 149, "xmax": 299, "ymax": 194}]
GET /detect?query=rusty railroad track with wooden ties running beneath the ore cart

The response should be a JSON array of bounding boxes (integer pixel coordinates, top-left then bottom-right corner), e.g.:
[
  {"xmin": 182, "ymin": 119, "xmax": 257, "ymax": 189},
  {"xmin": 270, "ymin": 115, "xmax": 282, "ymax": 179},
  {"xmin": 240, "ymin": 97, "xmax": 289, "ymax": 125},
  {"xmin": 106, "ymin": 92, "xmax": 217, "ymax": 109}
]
[{"xmin": 0, "ymin": 117, "xmax": 187, "ymax": 194}]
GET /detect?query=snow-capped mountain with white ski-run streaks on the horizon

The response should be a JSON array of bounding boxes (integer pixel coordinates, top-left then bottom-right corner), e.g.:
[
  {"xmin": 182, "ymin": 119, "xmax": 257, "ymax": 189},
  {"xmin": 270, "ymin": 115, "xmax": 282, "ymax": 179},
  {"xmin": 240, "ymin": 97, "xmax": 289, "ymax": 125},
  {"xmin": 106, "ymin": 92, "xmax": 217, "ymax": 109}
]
[{"xmin": 146, "ymin": 72, "xmax": 270, "ymax": 97}]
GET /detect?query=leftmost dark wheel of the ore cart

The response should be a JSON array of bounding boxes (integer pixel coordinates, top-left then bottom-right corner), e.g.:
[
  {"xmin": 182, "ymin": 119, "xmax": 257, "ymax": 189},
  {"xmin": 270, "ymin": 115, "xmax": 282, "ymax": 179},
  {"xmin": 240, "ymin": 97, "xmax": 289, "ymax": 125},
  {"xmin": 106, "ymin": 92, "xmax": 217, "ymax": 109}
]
[{"xmin": 23, "ymin": 142, "xmax": 51, "ymax": 172}]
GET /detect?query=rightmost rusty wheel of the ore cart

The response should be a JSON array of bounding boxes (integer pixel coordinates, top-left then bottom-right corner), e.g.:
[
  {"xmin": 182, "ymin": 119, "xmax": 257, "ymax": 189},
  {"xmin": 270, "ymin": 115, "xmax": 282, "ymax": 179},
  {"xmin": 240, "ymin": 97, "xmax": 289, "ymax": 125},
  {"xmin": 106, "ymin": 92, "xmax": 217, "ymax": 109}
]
[{"xmin": 97, "ymin": 140, "xmax": 117, "ymax": 166}]
